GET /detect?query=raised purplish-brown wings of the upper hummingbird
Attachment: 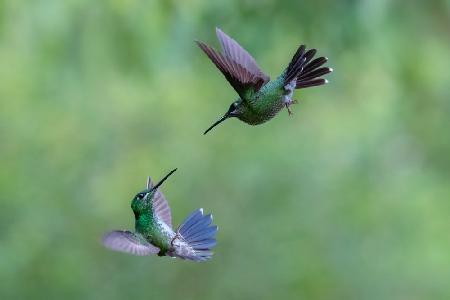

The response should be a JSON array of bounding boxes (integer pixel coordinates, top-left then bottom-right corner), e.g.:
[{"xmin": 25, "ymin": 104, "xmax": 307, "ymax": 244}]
[{"xmin": 197, "ymin": 28, "xmax": 270, "ymax": 99}]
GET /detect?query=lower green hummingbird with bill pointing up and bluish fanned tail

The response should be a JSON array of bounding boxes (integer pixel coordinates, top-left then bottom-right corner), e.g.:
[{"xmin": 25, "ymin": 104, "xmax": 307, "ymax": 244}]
[{"xmin": 102, "ymin": 169, "xmax": 218, "ymax": 262}]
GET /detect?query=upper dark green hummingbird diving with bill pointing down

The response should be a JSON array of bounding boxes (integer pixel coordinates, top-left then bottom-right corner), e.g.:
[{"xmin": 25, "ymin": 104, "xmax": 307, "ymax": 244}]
[{"xmin": 196, "ymin": 28, "xmax": 333, "ymax": 134}]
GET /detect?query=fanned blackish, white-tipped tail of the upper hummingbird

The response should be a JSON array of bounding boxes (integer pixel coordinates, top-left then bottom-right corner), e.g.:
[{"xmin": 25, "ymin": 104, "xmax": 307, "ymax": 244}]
[{"xmin": 284, "ymin": 45, "xmax": 333, "ymax": 89}]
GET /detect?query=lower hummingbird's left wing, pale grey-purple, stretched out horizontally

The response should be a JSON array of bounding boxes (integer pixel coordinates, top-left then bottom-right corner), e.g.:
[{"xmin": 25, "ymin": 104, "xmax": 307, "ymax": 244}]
[{"xmin": 102, "ymin": 230, "xmax": 159, "ymax": 256}]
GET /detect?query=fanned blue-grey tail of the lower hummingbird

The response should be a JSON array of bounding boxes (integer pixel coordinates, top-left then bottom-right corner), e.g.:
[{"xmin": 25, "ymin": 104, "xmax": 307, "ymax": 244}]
[{"xmin": 177, "ymin": 208, "xmax": 218, "ymax": 261}]
